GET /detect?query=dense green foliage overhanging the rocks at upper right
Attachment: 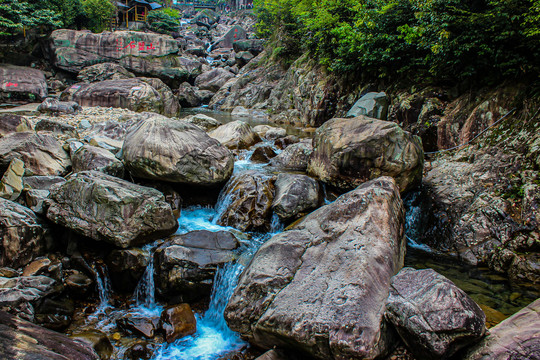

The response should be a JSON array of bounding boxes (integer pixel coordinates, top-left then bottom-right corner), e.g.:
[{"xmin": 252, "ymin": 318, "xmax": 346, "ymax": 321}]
[{"xmin": 255, "ymin": 0, "xmax": 540, "ymax": 83}]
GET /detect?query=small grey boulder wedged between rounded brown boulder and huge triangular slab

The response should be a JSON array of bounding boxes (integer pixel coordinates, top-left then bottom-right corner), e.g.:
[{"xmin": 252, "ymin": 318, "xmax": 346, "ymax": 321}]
[{"xmin": 272, "ymin": 174, "xmax": 321, "ymax": 220}]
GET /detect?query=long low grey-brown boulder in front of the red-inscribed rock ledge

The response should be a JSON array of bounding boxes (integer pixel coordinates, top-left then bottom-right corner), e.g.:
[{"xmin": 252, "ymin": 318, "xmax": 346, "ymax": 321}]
[{"xmin": 61, "ymin": 78, "xmax": 180, "ymax": 116}]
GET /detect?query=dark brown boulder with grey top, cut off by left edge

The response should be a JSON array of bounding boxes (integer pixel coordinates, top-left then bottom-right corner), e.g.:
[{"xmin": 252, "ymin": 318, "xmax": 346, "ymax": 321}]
[{"xmin": 0, "ymin": 198, "xmax": 45, "ymax": 268}]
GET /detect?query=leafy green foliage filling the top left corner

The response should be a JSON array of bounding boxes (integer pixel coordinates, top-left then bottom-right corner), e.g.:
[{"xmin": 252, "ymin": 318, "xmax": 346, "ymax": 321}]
[{"xmin": 0, "ymin": 0, "xmax": 62, "ymax": 35}]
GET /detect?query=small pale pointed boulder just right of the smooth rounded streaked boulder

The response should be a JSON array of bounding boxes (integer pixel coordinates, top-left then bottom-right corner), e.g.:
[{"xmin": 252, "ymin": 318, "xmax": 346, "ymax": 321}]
[{"xmin": 208, "ymin": 120, "xmax": 261, "ymax": 149}]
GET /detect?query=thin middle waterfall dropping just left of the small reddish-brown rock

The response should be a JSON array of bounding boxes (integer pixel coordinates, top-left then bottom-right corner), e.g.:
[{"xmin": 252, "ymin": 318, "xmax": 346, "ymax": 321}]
[{"xmin": 134, "ymin": 244, "xmax": 162, "ymax": 314}]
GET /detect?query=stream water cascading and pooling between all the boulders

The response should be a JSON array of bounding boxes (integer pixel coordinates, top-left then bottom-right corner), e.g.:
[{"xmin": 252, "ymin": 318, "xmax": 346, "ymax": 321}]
[{"xmin": 73, "ymin": 109, "xmax": 539, "ymax": 360}]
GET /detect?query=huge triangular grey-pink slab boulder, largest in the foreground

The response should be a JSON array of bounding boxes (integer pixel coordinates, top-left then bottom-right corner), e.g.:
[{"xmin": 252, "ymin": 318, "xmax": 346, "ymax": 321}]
[{"xmin": 225, "ymin": 177, "xmax": 405, "ymax": 359}]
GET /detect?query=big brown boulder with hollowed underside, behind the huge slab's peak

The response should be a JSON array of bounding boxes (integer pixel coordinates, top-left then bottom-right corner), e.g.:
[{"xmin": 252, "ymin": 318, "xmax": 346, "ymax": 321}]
[{"xmin": 308, "ymin": 116, "xmax": 424, "ymax": 192}]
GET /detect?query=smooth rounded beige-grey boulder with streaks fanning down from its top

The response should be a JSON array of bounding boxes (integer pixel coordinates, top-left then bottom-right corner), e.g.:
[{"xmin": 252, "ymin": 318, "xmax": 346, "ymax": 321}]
[{"xmin": 122, "ymin": 115, "xmax": 234, "ymax": 186}]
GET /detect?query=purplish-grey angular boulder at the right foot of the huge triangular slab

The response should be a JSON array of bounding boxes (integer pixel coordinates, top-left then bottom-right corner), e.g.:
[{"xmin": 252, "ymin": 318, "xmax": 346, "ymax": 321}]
[{"xmin": 386, "ymin": 268, "xmax": 486, "ymax": 360}]
